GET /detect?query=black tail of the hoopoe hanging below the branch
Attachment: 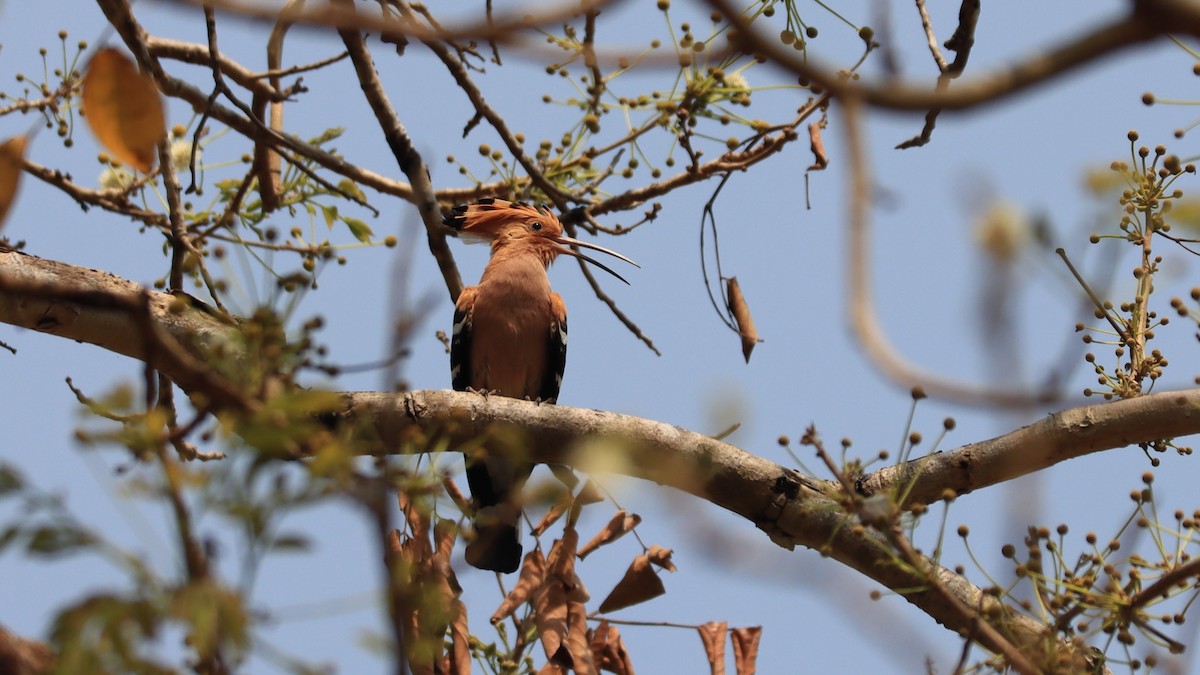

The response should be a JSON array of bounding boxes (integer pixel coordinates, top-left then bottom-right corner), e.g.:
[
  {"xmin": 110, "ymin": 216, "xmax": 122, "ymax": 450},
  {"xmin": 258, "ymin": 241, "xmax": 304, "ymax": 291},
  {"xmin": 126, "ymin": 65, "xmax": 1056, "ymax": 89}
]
[{"xmin": 467, "ymin": 458, "xmax": 533, "ymax": 573}]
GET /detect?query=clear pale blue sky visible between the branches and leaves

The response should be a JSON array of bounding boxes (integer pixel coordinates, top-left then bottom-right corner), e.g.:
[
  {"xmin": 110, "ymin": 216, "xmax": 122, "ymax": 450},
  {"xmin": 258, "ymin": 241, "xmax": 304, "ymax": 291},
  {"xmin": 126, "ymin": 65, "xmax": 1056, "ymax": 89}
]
[{"xmin": 0, "ymin": 1, "xmax": 1196, "ymax": 673}]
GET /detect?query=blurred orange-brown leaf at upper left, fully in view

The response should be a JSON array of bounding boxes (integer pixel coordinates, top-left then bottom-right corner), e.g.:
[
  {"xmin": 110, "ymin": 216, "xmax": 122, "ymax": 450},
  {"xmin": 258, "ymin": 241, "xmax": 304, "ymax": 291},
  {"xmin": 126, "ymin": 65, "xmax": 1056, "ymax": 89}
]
[{"xmin": 83, "ymin": 48, "xmax": 167, "ymax": 173}]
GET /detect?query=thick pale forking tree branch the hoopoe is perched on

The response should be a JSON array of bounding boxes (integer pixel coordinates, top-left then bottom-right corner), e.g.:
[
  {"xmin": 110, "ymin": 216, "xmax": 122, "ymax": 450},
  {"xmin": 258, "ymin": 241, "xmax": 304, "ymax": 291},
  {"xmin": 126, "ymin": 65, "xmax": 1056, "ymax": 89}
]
[{"xmin": 0, "ymin": 250, "xmax": 1180, "ymax": 658}]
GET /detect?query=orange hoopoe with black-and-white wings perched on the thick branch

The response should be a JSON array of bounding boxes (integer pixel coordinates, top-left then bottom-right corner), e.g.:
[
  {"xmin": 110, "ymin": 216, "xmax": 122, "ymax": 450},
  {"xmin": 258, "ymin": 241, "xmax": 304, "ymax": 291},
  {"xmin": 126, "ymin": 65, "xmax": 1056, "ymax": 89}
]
[{"xmin": 443, "ymin": 199, "xmax": 637, "ymax": 572}]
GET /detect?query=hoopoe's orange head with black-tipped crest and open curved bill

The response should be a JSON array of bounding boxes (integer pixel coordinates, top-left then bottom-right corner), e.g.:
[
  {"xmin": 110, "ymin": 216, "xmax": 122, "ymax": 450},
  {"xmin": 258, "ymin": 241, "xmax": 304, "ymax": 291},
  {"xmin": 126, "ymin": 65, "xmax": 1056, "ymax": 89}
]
[{"xmin": 442, "ymin": 199, "xmax": 638, "ymax": 283}]
